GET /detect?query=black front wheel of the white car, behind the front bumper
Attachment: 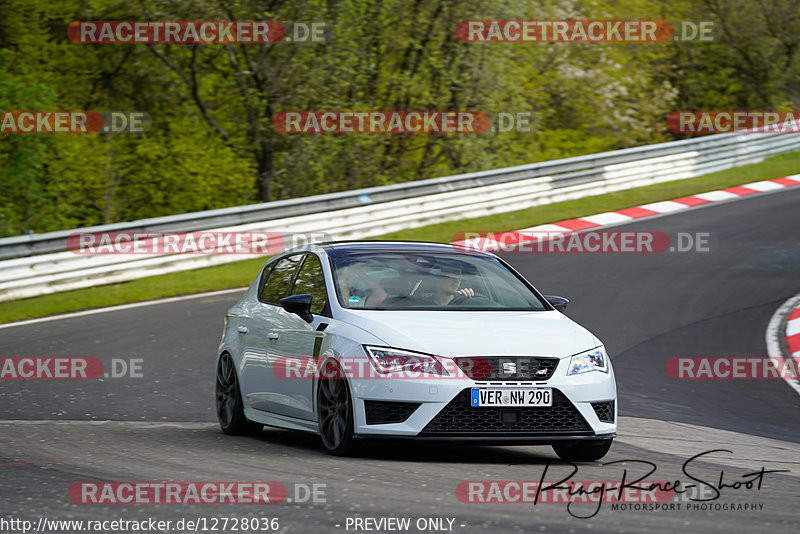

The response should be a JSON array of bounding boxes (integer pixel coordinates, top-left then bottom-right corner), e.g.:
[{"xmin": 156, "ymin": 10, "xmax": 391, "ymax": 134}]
[{"xmin": 317, "ymin": 360, "xmax": 356, "ymax": 456}]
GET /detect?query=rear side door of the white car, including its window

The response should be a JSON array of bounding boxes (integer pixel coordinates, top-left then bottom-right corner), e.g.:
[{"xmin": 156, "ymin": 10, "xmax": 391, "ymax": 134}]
[{"xmin": 237, "ymin": 253, "xmax": 304, "ymax": 411}]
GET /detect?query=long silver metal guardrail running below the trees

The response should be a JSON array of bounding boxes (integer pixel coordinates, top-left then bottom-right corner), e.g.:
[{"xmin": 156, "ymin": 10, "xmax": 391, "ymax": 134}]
[{"xmin": 0, "ymin": 129, "xmax": 800, "ymax": 301}]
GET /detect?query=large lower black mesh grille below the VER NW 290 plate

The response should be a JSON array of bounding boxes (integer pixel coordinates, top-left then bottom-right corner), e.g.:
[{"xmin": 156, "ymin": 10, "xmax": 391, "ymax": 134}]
[{"xmin": 420, "ymin": 388, "xmax": 592, "ymax": 437}]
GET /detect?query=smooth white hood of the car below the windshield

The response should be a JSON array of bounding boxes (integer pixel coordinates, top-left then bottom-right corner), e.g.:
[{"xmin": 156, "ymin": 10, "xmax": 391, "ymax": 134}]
[{"xmin": 338, "ymin": 310, "xmax": 600, "ymax": 358}]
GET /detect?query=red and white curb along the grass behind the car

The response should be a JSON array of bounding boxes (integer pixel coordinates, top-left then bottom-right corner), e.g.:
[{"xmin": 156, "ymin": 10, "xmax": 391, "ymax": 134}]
[{"xmin": 451, "ymin": 174, "xmax": 800, "ymax": 251}]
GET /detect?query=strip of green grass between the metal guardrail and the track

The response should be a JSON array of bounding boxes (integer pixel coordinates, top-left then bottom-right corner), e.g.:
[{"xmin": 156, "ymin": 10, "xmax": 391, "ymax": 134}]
[{"xmin": 0, "ymin": 152, "xmax": 800, "ymax": 323}]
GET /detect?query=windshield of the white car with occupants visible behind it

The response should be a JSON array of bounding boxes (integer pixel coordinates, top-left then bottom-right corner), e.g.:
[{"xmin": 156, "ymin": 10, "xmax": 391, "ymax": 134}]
[{"xmin": 331, "ymin": 252, "xmax": 548, "ymax": 311}]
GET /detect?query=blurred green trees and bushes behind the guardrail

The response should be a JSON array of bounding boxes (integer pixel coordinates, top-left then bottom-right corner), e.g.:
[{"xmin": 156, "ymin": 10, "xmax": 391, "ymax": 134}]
[{"xmin": 0, "ymin": 0, "xmax": 800, "ymax": 236}]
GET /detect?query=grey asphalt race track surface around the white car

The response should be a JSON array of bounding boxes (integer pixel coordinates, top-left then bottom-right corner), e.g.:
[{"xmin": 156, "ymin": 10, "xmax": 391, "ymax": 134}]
[{"xmin": 0, "ymin": 189, "xmax": 800, "ymax": 533}]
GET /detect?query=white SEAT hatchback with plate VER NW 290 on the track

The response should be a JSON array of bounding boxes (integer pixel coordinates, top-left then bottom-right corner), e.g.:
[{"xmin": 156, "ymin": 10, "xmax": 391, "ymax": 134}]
[{"xmin": 216, "ymin": 241, "xmax": 617, "ymax": 461}]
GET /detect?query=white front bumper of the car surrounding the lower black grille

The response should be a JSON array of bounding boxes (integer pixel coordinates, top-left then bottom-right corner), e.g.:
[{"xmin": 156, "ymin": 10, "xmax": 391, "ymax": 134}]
[{"xmin": 350, "ymin": 359, "xmax": 617, "ymax": 443}]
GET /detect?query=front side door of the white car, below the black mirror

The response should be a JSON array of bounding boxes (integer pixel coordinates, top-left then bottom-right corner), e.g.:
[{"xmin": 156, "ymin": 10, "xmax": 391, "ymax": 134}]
[{"xmin": 266, "ymin": 253, "xmax": 330, "ymax": 421}]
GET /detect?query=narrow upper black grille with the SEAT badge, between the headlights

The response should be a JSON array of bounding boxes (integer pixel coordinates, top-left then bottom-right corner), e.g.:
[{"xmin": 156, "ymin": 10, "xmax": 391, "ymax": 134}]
[{"xmin": 453, "ymin": 356, "xmax": 558, "ymax": 381}]
